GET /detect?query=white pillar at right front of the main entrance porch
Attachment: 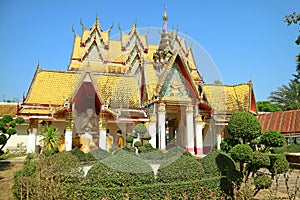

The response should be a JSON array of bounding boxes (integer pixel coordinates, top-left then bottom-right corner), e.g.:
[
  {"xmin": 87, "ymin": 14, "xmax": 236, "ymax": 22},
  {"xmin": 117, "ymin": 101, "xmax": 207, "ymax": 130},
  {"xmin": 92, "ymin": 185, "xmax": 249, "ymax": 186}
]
[{"xmin": 185, "ymin": 105, "xmax": 195, "ymax": 154}]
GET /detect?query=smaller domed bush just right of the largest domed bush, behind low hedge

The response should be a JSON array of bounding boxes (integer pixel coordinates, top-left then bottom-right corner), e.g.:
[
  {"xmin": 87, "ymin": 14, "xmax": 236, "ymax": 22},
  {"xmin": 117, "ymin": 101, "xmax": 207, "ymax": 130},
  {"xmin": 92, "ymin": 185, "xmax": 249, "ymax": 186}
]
[{"xmin": 157, "ymin": 155, "xmax": 204, "ymax": 183}]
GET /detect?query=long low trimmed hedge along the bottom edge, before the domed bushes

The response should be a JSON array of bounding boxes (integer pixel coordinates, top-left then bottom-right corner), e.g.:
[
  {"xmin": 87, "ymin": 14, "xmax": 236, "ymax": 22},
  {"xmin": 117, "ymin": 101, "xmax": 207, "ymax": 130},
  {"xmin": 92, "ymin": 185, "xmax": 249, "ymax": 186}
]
[{"xmin": 70, "ymin": 177, "xmax": 221, "ymax": 200}]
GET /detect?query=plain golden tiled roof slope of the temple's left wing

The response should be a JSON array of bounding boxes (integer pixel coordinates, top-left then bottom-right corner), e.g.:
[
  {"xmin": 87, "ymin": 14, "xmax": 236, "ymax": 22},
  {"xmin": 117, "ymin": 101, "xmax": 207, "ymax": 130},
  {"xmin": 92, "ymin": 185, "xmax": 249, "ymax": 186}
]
[{"xmin": 25, "ymin": 70, "xmax": 81, "ymax": 105}]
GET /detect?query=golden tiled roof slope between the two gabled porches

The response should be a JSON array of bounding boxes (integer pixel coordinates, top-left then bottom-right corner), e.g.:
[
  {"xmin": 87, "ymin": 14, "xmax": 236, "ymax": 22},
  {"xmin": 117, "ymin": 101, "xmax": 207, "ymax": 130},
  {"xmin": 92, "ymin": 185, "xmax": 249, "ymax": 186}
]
[{"xmin": 94, "ymin": 75, "xmax": 140, "ymax": 108}]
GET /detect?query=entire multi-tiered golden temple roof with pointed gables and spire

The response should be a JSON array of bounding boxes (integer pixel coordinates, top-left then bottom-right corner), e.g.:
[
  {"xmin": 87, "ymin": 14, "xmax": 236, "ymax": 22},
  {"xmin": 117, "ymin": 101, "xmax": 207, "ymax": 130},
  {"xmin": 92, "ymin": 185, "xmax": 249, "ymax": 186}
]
[{"xmin": 19, "ymin": 13, "xmax": 256, "ymax": 122}]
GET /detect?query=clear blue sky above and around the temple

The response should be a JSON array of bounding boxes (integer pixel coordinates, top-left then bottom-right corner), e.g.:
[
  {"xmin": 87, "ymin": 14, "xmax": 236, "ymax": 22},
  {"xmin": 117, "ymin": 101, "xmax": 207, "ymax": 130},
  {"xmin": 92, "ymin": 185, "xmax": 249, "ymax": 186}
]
[{"xmin": 0, "ymin": 0, "xmax": 300, "ymax": 101}]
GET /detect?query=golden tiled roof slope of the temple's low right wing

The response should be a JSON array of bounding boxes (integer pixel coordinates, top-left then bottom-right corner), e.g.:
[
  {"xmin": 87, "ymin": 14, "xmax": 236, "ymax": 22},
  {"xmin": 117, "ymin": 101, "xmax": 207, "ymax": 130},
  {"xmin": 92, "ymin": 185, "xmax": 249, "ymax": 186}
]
[{"xmin": 202, "ymin": 83, "xmax": 251, "ymax": 114}]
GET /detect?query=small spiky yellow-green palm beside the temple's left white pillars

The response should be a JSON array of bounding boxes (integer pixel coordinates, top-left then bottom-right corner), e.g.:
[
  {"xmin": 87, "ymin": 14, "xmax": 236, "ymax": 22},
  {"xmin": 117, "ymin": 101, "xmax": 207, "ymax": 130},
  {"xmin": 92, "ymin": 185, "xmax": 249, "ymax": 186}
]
[{"xmin": 40, "ymin": 125, "xmax": 59, "ymax": 150}]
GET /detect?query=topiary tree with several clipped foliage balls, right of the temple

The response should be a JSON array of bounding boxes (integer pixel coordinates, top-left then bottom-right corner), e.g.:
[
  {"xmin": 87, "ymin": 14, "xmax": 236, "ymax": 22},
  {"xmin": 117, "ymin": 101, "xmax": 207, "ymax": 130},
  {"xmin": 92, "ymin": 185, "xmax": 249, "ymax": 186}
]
[{"xmin": 221, "ymin": 112, "xmax": 289, "ymax": 198}]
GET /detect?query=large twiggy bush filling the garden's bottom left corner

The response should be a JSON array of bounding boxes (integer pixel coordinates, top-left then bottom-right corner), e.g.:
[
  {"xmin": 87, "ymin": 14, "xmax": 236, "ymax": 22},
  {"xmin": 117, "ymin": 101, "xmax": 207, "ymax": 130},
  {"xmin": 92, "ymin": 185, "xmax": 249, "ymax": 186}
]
[{"xmin": 13, "ymin": 152, "xmax": 84, "ymax": 199}]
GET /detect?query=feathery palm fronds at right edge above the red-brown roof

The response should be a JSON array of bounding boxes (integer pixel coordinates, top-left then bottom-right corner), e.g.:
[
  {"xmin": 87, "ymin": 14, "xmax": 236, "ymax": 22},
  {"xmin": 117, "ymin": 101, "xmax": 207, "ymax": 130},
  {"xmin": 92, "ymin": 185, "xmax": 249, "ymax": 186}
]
[{"xmin": 269, "ymin": 80, "xmax": 300, "ymax": 110}]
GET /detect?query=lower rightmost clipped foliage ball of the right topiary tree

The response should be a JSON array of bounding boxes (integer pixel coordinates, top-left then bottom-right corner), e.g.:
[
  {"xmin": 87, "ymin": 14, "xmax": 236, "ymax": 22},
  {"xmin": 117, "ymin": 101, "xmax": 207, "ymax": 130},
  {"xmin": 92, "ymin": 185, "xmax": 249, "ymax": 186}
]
[{"xmin": 267, "ymin": 154, "xmax": 289, "ymax": 177}]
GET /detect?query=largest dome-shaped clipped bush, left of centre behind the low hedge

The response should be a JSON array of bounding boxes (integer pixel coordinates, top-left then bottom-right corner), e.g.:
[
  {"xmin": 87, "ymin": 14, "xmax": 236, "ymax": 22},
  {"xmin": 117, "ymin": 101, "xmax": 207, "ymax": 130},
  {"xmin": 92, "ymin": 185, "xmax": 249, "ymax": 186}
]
[{"xmin": 86, "ymin": 150, "xmax": 155, "ymax": 187}]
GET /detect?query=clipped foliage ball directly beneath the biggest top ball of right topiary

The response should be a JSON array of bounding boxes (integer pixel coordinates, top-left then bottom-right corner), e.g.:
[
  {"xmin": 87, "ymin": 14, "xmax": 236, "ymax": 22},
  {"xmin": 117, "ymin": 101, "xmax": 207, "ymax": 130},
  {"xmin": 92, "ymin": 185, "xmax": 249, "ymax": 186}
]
[{"xmin": 230, "ymin": 144, "xmax": 253, "ymax": 163}]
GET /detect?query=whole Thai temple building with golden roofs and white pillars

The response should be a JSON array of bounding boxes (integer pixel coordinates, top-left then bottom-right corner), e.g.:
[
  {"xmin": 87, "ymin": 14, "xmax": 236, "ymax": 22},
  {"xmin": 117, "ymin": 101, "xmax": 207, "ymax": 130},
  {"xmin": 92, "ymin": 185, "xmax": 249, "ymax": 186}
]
[{"xmin": 17, "ymin": 11, "xmax": 257, "ymax": 155}]
